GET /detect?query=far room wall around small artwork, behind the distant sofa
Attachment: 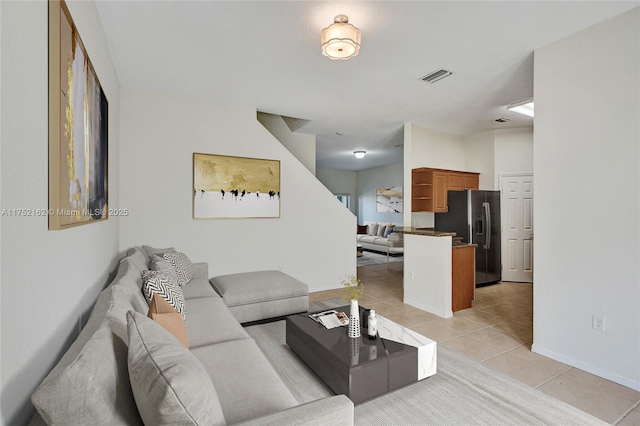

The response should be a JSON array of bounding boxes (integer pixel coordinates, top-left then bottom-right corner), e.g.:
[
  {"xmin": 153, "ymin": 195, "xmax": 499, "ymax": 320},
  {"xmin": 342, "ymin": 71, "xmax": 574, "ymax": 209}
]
[{"xmin": 358, "ymin": 163, "xmax": 402, "ymax": 225}]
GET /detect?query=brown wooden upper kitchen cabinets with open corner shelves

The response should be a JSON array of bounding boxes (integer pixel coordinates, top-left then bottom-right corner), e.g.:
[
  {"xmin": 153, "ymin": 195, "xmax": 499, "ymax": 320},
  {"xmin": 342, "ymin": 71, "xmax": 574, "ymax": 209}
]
[{"xmin": 411, "ymin": 167, "xmax": 480, "ymax": 213}]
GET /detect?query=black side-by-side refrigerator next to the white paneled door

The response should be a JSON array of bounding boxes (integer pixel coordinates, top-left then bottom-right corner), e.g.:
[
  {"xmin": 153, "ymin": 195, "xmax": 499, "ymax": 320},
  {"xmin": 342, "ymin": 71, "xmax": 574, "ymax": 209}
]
[{"xmin": 434, "ymin": 189, "xmax": 502, "ymax": 286}]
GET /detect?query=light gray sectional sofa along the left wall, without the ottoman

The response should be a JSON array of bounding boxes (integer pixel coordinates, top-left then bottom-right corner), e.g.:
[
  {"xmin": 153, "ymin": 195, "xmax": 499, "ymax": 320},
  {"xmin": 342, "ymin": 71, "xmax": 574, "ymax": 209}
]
[{"xmin": 30, "ymin": 248, "xmax": 353, "ymax": 425}]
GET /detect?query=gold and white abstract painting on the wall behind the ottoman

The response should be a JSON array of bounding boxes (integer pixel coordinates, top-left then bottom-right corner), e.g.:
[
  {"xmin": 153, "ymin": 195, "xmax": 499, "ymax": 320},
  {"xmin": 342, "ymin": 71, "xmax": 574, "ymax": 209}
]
[{"xmin": 193, "ymin": 153, "xmax": 280, "ymax": 219}]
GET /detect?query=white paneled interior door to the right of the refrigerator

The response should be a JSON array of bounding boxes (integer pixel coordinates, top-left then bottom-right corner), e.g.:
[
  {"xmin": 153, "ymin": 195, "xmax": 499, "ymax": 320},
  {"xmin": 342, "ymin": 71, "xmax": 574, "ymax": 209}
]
[{"xmin": 500, "ymin": 174, "xmax": 533, "ymax": 282}]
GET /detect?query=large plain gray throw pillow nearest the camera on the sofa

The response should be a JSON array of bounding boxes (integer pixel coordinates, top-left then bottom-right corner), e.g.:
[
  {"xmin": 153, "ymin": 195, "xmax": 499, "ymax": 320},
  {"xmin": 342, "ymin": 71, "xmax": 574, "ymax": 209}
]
[{"xmin": 127, "ymin": 311, "xmax": 226, "ymax": 426}]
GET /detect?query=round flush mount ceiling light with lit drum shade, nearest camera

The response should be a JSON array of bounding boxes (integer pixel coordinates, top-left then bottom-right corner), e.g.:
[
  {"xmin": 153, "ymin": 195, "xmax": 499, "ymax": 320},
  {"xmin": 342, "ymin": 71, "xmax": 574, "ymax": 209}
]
[{"xmin": 320, "ymin": 15, "xmax": 360, "ymax": 61}]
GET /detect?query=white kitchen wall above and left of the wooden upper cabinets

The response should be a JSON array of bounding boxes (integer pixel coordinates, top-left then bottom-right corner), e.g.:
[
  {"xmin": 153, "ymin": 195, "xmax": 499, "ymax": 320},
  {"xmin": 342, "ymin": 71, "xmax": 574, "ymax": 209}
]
[{"xmin": 404, "ymin": 123, "xmax": 465, "ymax": 227}]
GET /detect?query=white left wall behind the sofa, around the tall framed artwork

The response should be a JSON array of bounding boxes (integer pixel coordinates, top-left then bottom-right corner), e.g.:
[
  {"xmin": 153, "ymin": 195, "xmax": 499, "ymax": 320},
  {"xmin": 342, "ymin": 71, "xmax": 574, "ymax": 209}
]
[{"xmin": 0, "ymin": 1, "xmax": 120, "ymax": 424}]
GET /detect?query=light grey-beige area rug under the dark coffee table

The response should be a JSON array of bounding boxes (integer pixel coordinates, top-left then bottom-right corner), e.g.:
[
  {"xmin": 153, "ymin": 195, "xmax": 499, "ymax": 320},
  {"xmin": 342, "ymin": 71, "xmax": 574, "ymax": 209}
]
[{"xmin": 246, "ymin": 301, "xmax": 606, "ymax": 426}]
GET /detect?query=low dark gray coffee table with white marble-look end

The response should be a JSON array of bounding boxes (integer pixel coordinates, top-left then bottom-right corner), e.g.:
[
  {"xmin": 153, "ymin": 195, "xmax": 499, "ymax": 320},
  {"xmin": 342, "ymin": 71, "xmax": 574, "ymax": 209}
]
[{"xmin": 286, "ymin": 306, "xmax": 437, "ymax": 404}]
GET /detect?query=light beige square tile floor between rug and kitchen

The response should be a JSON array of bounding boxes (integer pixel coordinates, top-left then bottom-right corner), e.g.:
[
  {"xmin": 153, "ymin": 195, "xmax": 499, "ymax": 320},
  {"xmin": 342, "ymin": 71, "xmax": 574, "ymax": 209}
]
[{"xmin": 309, "ymin": 263, "xmax": 640, "ymax": 426}]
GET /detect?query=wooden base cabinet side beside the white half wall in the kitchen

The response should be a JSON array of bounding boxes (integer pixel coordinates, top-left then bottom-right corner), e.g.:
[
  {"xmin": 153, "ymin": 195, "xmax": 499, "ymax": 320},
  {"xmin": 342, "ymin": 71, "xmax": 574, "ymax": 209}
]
[{"xmin": 451, "ymin": 245, "xmax": 476, "ymax": 312}]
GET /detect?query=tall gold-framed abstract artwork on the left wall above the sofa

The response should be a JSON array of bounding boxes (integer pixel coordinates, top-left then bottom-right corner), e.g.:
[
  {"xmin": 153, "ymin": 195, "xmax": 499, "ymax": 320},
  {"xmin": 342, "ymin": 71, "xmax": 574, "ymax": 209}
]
[{"xmin": 49, "ymin": 0, "xmax": 109, "ymax": 230}]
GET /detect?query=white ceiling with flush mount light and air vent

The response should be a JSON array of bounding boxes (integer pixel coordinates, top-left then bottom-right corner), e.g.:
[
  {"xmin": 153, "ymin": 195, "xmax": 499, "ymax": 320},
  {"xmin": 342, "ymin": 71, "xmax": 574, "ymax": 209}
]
[{"xmin": 92, "ymin": 0, "xmax": 640, "ymax": 170}]
